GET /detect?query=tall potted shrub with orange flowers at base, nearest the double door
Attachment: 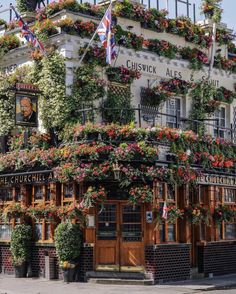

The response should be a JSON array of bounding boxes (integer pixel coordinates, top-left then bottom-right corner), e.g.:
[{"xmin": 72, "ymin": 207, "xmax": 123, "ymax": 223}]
[{"xmin": 55, "ymin": 221, "xmax": 82, "ymax": 283}]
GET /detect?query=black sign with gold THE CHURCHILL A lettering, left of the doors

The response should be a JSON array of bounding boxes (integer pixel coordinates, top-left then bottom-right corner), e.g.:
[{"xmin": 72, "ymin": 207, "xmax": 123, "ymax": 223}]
[{"xmin": 0, "ymin": 171, "xmax": 53, "ymax": 186}]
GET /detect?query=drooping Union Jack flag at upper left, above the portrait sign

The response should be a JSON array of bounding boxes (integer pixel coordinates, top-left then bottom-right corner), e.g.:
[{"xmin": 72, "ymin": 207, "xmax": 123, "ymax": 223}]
[{"xmin": 11, "ymin": 6, "xmax": 45, "ymax": 54}]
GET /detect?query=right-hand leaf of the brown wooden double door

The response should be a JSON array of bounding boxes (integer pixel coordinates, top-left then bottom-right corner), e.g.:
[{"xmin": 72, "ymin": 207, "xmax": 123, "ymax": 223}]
[{"xmin": 120, "ymin": 204, "xmax": 144, "ymax": 271}]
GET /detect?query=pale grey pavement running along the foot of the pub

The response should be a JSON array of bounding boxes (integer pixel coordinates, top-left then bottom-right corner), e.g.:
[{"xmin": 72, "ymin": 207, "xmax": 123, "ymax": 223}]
[{"xmin": 0, "ymin": 274, "xmax": 236, "ymax": 294}]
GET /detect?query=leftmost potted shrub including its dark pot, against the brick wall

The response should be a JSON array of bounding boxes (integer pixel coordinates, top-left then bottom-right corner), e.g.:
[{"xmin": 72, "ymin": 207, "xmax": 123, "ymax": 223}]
[{"xmin": 10, "ymin": 224, "xmax": 32, "ymax": 278}]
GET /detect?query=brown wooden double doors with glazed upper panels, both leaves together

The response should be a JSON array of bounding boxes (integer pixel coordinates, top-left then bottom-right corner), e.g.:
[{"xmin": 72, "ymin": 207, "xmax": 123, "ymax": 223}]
[{"xmin": 95, "ymin": 202, "xmax": 144, "ymax": 271}]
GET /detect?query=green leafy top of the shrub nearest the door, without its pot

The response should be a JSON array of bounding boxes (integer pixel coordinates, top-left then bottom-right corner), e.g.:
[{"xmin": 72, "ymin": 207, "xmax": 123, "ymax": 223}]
[{"xmin": 55, "ymin": 222, "xmax": 82, "ymax": 263}]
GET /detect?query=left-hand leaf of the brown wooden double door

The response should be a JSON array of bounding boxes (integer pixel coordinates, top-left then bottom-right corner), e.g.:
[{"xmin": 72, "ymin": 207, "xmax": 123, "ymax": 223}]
[{"xmin": 95, "ymin": 203, "xmax": 119, "ymax": 271}]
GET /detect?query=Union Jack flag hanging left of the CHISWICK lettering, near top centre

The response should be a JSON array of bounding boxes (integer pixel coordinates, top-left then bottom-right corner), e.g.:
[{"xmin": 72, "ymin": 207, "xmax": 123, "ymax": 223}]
[{"xmin": 97, "ymin": 4, "xmax": 116, "ymax": 64}]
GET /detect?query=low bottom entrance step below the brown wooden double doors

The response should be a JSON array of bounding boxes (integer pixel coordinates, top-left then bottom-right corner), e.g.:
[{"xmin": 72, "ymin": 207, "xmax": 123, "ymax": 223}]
[{"xmin": 88, "ymin": 278, "xmax": 154, "ymax": 286}]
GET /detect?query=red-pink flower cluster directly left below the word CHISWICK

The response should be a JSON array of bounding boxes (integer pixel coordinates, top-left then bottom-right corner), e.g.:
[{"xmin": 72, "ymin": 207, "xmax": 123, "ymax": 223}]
[{"xmin": 106, "ymin": 66, "xmax": 141, "ymax": 84}]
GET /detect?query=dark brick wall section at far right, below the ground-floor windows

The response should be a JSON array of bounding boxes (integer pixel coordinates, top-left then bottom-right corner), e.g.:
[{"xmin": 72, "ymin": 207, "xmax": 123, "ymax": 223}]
[{"xmin": 198, "ymin": 241, "xmax": 236, "ymax": 276}]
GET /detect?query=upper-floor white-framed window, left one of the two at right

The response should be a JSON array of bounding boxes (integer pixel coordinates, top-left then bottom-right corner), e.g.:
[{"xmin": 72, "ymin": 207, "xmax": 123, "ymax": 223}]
[{"xmin": 166, "ymin": 98, "xmax": 181, "ymax": 128}]
